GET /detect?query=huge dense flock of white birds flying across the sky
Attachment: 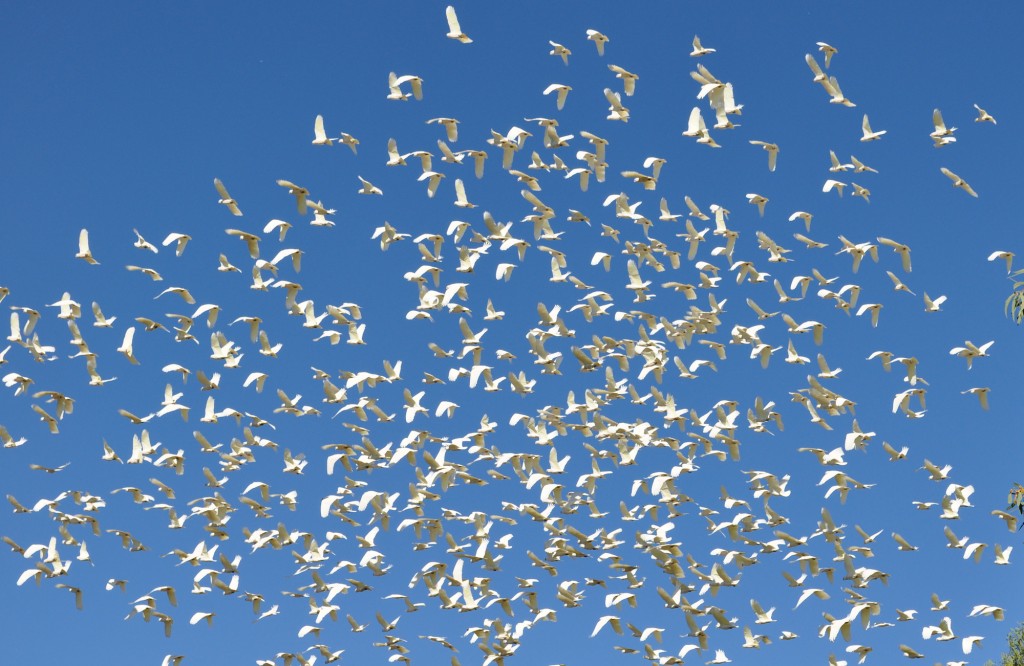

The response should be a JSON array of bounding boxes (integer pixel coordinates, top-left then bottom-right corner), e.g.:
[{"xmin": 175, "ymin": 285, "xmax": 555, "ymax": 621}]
[{"xmin": 0, "ymin": 7, "xmax": 1018, "ymax": 666}]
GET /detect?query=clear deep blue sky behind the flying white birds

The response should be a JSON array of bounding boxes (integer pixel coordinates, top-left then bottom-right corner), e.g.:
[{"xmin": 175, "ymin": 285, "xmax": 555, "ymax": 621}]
[{"xmin": 0, "ymin": 2, "xmax": 1024, "ymax": 664}]
